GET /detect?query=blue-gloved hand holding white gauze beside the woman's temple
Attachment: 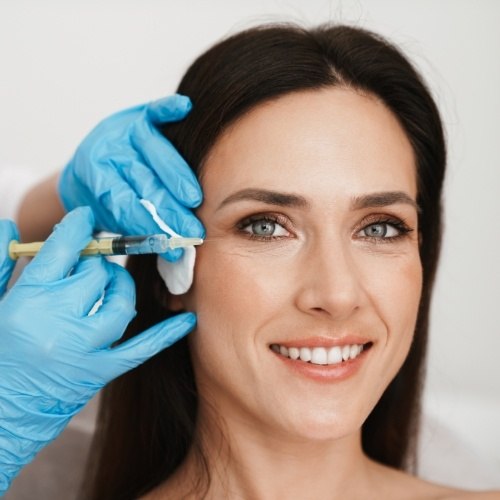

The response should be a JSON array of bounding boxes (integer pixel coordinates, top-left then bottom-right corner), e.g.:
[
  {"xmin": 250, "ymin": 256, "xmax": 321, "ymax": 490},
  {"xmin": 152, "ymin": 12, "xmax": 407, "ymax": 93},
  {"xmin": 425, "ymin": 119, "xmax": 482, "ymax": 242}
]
[{"xmin": 58, "ymin": 94, "xmax": 204, "ymax": 261}]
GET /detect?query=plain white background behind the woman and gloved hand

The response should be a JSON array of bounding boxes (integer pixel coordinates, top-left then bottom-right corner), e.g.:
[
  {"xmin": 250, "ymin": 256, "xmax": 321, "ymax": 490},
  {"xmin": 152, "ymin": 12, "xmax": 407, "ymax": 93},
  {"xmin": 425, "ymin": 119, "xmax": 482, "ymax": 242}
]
[{"xmin": 0, "ymin": 0, "xmax": 500, "ymax": 488}]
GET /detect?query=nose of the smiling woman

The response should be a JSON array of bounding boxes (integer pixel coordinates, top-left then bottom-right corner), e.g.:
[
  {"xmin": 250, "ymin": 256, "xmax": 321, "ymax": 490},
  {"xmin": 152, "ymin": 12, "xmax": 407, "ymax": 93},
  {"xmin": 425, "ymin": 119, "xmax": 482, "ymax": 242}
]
[{"xmin": 295, "ymin": 234, "xmax": 367, "ymax": 320}]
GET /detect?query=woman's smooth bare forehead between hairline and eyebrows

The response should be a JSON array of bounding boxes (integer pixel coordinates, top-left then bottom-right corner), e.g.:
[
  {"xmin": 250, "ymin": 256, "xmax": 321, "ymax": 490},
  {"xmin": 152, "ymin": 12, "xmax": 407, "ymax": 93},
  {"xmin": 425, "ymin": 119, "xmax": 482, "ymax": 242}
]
[{"xmin": 201, "ymin": 87, "xmax": 416, "ymax": 205}]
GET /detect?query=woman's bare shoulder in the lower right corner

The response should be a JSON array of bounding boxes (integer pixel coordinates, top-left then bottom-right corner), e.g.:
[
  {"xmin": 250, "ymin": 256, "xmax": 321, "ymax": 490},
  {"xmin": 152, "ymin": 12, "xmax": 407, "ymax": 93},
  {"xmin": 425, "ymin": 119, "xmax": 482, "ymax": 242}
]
[{"xmin": 368, "ymin": 464, "xmax": 500, "ymax": 500}]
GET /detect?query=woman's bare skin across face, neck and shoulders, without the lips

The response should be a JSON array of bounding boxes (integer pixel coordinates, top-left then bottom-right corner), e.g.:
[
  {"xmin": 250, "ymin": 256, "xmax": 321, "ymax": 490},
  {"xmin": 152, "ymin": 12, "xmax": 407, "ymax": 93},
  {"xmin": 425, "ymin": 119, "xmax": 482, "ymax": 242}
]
[{"xmin": 145, "ymin": 88, "xmax": 492, "ymax": 499}]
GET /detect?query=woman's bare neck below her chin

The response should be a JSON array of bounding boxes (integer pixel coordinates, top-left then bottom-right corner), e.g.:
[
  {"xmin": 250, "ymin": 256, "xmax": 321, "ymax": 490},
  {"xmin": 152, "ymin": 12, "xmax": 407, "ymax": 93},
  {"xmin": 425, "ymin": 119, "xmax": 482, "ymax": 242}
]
[{"xmin": 164, "ymin": 402, "xmax": 373, "ymax": 499}]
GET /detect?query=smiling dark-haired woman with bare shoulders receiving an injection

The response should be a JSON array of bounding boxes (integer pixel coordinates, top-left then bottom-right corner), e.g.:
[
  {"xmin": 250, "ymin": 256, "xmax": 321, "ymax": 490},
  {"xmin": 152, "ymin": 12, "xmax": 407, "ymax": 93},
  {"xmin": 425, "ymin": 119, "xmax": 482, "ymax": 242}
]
[{"xmin": 81, "ymin": 22, "xmax": 493, "ymax": 499}]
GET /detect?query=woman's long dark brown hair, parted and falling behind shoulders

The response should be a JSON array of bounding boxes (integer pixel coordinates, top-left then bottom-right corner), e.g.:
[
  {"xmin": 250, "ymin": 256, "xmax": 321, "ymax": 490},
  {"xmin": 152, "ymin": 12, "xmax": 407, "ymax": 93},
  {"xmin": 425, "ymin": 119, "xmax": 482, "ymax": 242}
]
[{"xmin": 83, "ymin": 25, "xmax": 446, "ymax": 500}]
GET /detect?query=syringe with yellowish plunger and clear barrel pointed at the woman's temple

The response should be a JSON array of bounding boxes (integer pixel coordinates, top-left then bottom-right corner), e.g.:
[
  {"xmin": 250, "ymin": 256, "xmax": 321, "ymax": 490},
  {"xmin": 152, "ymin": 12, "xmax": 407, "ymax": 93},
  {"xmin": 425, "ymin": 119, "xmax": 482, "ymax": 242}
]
[{"xmin": 9, "ymin": 234, "xmax": 203, "ymax": 260}]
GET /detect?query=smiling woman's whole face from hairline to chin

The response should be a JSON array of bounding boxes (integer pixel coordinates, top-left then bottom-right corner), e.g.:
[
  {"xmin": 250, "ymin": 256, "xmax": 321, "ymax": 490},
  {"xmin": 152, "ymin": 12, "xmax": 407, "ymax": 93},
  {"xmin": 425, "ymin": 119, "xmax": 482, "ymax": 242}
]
[{"xmin": 181, "ymin": 88, "xmax": 422, "ymax": 439}]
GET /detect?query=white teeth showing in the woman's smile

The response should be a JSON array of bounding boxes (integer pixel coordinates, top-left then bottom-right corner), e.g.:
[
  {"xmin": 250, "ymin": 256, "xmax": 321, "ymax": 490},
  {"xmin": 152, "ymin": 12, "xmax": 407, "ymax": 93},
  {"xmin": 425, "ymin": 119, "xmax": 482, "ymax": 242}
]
[{"xmin": 270, "ymin": 342, "xmax": 372, "ymax": 366}]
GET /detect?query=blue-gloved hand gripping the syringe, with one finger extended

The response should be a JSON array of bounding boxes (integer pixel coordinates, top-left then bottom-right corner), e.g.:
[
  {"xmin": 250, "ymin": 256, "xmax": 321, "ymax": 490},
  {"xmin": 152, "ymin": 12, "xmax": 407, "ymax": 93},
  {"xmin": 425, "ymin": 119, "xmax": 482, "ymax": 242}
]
[{"xmin": 0, "ymin": 207, "xmax": 195, "ymax": 496}]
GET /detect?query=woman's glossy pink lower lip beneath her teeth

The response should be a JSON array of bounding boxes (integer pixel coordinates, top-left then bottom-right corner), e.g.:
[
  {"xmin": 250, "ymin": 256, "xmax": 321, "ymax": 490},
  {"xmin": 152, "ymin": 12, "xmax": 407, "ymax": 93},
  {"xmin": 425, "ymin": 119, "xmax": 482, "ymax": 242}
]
[{"xmin": 270, "ymin": 349, "xmax": 369, "ymax": 382}]
